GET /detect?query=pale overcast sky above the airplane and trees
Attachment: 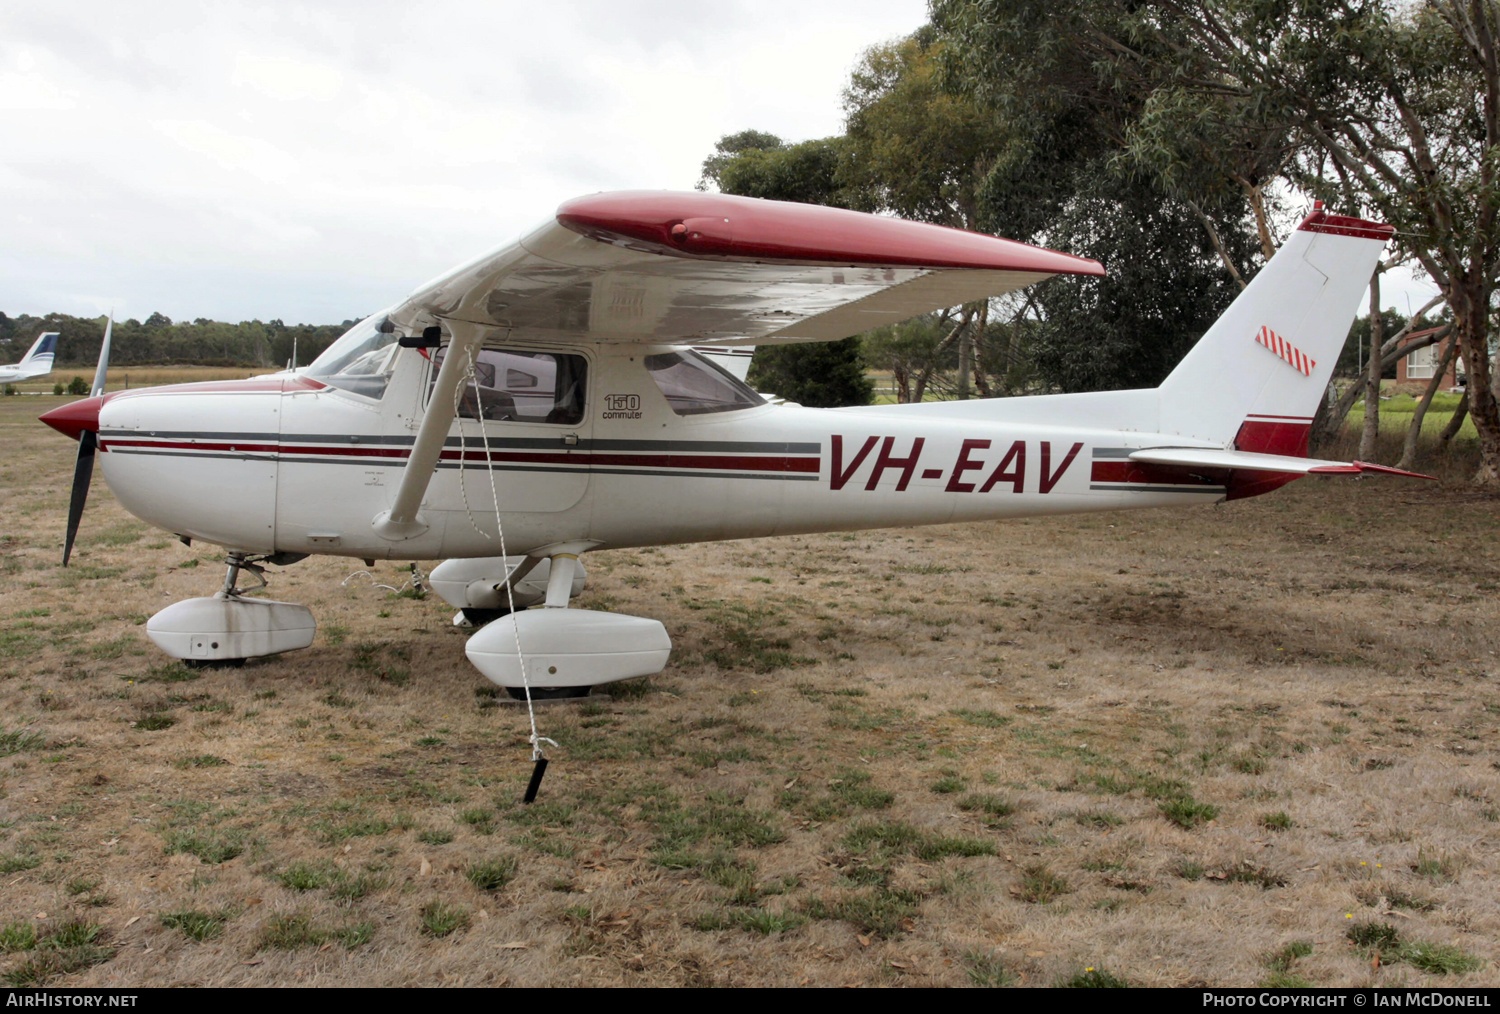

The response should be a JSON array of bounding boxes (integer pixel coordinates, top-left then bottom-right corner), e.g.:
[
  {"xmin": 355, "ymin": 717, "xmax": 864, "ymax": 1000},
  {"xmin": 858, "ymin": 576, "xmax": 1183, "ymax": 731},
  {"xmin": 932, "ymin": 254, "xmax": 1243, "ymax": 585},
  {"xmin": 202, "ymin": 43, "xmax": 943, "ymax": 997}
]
[{"xmin": 0, "ymin": 0, "xmax": 1431, "ymax": 323}]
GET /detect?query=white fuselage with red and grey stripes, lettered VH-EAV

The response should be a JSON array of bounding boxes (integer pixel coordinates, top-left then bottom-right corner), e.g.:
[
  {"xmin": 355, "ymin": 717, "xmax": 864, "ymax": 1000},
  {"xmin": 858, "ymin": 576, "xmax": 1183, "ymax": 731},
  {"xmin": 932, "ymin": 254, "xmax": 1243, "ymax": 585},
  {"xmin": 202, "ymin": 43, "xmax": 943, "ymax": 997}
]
[{"xmin": 99, "ymin": 345, "xmax": 1233, "ymax": 560}]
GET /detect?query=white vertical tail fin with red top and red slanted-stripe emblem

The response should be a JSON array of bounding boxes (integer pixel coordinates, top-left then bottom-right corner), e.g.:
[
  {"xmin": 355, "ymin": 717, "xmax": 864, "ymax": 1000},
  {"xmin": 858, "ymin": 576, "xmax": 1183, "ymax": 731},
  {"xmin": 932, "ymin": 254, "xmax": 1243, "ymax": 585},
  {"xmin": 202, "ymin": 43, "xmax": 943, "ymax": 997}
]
[{"xmin": 1158, "ymin": 207, "xmax": 1395, "ymax": 456}]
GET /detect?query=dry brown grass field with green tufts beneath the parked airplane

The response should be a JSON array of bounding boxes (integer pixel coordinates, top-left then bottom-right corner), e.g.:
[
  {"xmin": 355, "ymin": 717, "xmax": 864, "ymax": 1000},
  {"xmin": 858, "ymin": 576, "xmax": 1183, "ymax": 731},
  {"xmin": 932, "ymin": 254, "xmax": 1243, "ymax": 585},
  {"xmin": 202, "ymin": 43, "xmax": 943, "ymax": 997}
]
[{"xmin": 0, "ymin": 396, "xmax": 1500, "ymax": 987}]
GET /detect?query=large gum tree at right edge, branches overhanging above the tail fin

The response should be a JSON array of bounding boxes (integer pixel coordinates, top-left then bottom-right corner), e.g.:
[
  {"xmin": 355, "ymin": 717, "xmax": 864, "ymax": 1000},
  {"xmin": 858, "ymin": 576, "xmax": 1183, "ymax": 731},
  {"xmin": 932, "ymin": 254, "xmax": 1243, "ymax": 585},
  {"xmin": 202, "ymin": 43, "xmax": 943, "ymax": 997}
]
[{"xmin": 935, "ymin": 0, "xmax": 1500, "ymax": 492}]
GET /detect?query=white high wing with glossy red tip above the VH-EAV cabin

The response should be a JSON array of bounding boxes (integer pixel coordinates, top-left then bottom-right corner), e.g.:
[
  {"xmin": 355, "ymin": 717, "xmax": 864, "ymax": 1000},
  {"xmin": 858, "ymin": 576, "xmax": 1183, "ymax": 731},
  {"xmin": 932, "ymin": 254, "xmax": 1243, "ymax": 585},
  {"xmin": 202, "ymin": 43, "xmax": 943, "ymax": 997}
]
[{"xmin": 381, "ymin": 192, "xmax": 1104, "ymax": 345}]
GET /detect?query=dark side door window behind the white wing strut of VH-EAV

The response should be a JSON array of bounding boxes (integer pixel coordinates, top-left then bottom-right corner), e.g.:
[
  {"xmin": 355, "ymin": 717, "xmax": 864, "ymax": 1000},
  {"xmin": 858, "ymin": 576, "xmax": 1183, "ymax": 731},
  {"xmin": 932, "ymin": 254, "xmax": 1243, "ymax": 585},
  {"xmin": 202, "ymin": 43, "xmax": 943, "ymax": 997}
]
[{"xmin": 428, "ymin": 347, "xmax": 588, "ymax": 426}]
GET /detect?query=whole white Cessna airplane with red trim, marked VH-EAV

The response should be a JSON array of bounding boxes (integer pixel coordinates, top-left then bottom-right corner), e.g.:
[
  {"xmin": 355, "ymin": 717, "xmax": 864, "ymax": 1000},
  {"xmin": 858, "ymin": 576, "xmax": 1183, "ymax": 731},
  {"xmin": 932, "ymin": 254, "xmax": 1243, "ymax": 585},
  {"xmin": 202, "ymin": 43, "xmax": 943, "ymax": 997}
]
[{"xmin": 42, "ymin": 192, "xmax": 1412, "ymax": 698}]
